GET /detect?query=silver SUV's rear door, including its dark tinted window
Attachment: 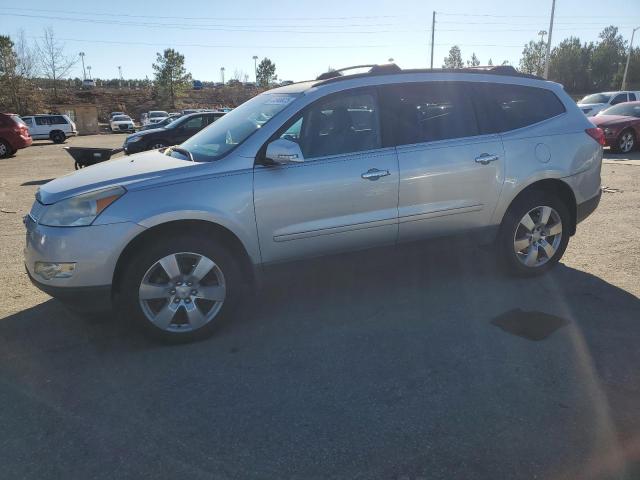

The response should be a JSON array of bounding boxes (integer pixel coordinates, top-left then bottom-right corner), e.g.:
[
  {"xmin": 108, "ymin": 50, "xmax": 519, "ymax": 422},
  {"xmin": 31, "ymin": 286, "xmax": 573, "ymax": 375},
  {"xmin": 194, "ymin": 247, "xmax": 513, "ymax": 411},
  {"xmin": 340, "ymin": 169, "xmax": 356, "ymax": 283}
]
[{"xmin": 381, "ymin": 82, "xmax": 504, "ymax": 241}]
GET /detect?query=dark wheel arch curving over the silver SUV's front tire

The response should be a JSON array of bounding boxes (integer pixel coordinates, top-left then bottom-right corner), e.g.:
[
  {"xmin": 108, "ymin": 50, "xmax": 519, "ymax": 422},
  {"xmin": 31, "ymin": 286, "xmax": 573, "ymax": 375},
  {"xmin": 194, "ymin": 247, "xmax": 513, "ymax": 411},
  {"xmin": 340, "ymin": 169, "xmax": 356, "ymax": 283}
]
[{"xmin": 112, "ymin": 220, "xmax": 257, "ymax": 295}]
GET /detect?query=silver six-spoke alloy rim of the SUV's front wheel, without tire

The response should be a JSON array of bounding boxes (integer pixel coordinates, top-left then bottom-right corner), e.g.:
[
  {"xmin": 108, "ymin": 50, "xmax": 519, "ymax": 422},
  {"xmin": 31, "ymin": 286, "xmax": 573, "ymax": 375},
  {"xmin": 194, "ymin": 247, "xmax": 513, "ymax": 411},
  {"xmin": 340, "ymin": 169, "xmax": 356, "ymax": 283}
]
[{"xmin": 138, "ymin": 252, "xmax": 227, "ymax": 332}]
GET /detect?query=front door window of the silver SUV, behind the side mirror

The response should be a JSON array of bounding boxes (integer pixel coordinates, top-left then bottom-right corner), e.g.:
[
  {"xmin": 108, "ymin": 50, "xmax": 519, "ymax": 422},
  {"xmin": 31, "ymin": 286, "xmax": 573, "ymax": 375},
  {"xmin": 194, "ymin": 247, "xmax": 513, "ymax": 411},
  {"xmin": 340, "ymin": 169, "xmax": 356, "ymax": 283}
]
[{"xmin": 280, "ymin": 92, "xmax": 381, "ymax": 159}]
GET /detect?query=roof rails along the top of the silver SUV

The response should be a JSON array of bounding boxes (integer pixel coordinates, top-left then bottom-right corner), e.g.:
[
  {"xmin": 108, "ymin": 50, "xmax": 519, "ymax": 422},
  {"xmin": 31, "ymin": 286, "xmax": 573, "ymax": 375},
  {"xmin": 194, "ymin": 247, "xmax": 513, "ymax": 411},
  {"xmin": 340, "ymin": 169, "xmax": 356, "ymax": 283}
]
[{"xmin": 315, "ymin": 63, "xmax": 544, "ymax": 85}]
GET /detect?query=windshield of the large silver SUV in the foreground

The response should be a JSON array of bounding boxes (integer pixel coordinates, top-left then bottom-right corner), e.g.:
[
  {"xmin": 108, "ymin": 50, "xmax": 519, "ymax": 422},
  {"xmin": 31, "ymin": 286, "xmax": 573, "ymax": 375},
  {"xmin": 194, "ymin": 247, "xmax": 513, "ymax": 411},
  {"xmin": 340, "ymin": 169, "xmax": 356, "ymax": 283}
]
[{"xmin": 182, "ymin": 93, "xmax": 299, "ymax": 162}]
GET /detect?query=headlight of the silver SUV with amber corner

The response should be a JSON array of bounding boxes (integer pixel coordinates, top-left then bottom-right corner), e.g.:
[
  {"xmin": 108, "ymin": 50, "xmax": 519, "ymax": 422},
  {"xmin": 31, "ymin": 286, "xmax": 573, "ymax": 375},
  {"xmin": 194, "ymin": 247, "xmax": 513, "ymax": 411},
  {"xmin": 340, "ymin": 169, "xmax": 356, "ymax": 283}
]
[{"xmin": 39, "ymin": 187, "xmax": 126, "ymax": 227}]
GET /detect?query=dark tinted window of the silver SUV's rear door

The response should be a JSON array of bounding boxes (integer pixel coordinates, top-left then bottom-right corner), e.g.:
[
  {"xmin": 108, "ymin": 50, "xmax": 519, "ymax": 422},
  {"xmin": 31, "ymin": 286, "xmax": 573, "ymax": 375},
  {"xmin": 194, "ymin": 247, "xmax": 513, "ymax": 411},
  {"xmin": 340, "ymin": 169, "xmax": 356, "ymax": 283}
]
[{"xmin": 381, "ymin": 82, "xmax": 478, "ymax": 145}]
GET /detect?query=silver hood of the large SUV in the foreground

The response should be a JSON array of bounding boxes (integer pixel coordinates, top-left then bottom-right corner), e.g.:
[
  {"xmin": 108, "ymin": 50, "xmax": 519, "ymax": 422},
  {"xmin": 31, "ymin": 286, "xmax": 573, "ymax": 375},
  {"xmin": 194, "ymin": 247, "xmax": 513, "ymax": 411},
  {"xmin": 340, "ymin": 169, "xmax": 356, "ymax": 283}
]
[{"xmin": 37, "ymin": 150, "xmax": 203, "ymax": 205}]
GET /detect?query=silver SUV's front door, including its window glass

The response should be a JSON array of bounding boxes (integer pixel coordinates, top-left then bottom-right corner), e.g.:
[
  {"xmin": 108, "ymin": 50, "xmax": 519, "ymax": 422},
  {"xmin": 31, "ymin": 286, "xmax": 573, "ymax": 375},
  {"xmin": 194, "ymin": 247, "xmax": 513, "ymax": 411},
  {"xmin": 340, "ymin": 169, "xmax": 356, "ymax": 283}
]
[{"xmin": 254, "ymin": 89, "xmax": 398, "ymax": 263}]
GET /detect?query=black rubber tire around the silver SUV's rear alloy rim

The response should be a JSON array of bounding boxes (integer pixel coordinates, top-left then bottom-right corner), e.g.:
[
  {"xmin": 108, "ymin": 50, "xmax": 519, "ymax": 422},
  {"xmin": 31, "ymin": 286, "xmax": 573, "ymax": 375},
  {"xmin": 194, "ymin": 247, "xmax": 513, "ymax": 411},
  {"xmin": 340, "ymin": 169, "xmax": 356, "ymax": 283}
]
[{"xmin": 496, "ymin": 190, "xmax": 571, "ymax": 276}]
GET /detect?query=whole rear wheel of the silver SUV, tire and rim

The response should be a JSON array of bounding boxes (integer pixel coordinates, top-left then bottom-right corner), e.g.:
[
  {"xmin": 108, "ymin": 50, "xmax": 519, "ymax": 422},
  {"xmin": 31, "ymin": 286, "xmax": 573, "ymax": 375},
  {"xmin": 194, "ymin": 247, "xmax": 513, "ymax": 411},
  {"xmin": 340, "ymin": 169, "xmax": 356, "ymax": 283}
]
[{"xmin": 498, "ymin": 192, "xmax": 571, "ymax": 276}]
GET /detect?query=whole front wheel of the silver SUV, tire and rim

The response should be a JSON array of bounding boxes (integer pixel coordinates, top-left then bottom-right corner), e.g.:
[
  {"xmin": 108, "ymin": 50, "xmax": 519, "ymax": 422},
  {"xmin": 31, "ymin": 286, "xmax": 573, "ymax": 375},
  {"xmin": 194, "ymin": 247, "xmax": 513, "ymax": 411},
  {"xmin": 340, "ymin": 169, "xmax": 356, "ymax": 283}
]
[{"xmin": 119, "ymin": 234, "xmax": 242, "ymax": 343}]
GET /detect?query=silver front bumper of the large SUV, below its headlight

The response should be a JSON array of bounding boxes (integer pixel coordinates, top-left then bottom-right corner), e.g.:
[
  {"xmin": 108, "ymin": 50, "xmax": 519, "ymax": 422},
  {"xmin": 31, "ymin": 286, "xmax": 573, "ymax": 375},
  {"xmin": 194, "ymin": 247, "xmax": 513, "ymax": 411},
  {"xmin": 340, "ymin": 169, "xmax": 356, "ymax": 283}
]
[{"xmin": 24, "ymin": 216, "xmax": 145, "ymax": 295}]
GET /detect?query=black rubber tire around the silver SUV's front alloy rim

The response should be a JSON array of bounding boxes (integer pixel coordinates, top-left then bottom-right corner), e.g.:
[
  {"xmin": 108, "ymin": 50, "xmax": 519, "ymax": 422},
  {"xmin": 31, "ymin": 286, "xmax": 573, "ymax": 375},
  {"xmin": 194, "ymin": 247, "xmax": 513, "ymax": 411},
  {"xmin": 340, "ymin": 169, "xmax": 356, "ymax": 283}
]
[{"xmin": 116, "ymin": 232, "xmax": 244, "ymax": 343}]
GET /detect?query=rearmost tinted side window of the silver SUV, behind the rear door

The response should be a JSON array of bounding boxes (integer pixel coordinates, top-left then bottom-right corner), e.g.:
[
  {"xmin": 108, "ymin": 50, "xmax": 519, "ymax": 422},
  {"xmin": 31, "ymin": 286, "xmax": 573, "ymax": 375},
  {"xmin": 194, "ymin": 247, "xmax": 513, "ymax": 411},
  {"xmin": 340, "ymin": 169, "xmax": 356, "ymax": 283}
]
[{"xmin": 473, "ymin": 83, "xmax": 565, "ymax": 133}]
